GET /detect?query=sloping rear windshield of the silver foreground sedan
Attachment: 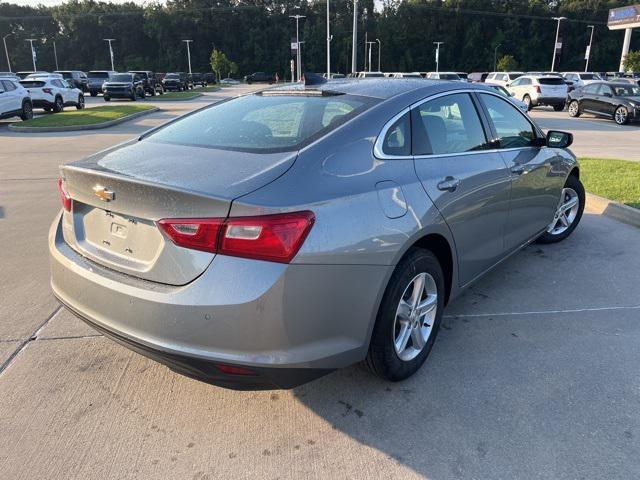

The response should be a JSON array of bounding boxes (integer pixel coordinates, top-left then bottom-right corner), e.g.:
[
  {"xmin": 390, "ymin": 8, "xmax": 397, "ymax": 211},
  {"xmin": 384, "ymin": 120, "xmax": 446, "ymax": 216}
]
[{"xmin": 148, "ymin": 95, "xmax": 373, "ymax": 153}]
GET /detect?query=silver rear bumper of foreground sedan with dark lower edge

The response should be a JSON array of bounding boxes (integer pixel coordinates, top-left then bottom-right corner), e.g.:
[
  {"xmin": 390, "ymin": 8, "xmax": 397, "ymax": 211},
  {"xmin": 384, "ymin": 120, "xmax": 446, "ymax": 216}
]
[{"xmin": 49, "ymin": 217, "xmax": 393, "ymax": 389}]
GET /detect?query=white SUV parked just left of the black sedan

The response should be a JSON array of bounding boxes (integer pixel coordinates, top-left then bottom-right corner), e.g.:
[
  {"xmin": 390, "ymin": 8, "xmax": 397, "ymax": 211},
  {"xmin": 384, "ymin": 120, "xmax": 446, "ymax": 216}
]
[{"xmin": 507, "ymin": 75, "xmax": 569, "ymax": 112}]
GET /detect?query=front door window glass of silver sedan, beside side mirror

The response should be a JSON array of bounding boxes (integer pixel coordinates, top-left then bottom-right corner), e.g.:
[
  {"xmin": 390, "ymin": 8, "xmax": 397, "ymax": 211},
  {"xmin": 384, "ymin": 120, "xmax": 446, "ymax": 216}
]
[{"xmin": 480, "ymin": 93, "xmax": 536, "ymax": 148}]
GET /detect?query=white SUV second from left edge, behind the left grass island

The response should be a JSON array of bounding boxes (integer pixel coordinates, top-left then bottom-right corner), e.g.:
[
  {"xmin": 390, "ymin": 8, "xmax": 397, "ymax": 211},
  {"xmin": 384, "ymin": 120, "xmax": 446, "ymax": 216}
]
[{"xmin": 20, "ymin": 74, "xmax": 84, "ymax": 113}]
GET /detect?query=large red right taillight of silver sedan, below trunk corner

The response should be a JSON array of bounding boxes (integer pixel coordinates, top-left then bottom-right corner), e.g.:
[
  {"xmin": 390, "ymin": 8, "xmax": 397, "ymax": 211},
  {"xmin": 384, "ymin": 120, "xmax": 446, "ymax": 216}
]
[{"xmin": 158, "ymin": 211, "xmax": 315, "ymax": 263}]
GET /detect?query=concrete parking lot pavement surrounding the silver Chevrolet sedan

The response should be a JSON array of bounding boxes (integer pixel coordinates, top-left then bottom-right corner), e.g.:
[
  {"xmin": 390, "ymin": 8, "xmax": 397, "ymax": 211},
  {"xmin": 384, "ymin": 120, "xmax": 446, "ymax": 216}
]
[{"xmin": 0, "ymin": 87, "xmax": 640, "ymax": 480}]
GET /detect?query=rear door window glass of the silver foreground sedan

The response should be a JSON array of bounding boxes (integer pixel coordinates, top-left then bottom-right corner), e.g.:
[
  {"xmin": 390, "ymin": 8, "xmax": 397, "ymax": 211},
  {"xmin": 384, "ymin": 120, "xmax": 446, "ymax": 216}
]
[{"xmin": 413, "ymin": 93, "xmax": 487, "ymax": 155}]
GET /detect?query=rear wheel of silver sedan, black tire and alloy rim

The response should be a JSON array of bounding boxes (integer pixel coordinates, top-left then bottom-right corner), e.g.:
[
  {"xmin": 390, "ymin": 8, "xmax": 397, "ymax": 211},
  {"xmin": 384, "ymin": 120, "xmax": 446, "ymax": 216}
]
[{"xmin": 365, "ymin": 248, "xmax": 445, "ymax": 382}]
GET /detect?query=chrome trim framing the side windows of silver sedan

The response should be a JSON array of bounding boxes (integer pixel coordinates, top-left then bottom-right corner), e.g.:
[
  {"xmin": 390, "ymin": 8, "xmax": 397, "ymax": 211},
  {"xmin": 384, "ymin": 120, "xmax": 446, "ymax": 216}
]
[{"xmin": 373, "ymin": 88, "xmax": 540, "ymax": 160}]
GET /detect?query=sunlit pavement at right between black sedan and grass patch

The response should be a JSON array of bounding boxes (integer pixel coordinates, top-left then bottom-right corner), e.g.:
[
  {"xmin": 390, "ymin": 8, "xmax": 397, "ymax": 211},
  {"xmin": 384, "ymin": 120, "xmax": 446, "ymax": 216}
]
[{"xmin": 531, "ymin": 108, "xmax": 640, "ymax": 161}]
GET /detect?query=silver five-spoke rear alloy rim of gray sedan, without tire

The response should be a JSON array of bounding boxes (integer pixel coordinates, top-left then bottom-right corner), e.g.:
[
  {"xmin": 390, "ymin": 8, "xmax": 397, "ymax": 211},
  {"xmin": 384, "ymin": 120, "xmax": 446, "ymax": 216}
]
[{"xmin": 393, "ymin": 272, "xmax": 438, "ymax": 362}]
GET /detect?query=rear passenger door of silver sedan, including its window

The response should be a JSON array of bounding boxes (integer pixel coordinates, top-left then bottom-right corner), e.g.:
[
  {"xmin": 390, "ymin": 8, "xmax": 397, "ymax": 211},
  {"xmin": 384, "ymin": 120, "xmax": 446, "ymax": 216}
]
[{"xmin": 411, "ymin": 92, "xmax": 510, "ymax": 285}]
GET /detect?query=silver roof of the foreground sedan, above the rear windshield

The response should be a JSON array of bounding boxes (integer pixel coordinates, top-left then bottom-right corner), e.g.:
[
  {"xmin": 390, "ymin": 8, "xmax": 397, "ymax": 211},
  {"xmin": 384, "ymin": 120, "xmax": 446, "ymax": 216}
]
[{"xmin": 265, "ymin": 77, "xmax": 486, "ymax": 100}]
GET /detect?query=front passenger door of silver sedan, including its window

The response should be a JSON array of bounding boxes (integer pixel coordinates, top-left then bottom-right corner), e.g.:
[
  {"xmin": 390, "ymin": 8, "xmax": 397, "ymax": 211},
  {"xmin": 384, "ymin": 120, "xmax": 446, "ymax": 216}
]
[{"xmin": 478, "ymin": 92, "xmax": 564, "ymax": 251}]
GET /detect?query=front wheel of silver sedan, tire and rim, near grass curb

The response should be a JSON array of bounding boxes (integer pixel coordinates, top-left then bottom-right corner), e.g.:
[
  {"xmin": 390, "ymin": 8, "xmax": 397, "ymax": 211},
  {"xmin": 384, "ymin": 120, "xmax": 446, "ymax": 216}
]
[{"xmin": 538, "ymin": 175, "xmax": 585, "ymax": 243}]
